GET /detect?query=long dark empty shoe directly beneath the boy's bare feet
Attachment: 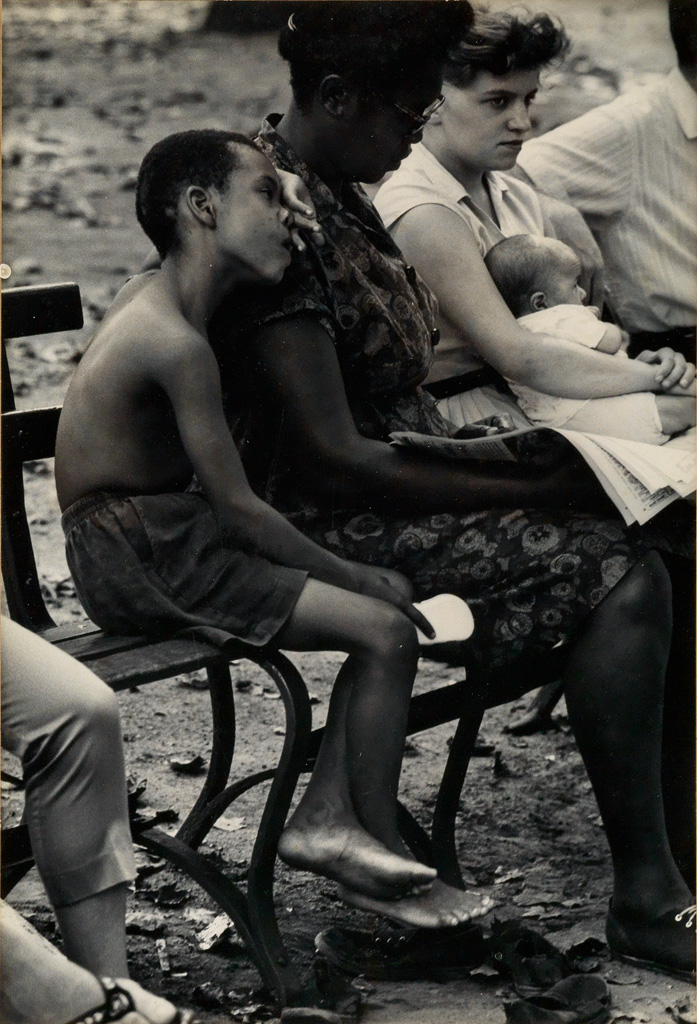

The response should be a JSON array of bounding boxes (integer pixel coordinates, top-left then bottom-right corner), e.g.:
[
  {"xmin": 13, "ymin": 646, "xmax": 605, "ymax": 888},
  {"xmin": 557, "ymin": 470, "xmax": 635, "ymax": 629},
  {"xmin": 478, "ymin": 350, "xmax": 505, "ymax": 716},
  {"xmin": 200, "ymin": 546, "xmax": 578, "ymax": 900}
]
[{"xmin": 314, "ymin": 922, "xmax": 489, "ymax": 981}]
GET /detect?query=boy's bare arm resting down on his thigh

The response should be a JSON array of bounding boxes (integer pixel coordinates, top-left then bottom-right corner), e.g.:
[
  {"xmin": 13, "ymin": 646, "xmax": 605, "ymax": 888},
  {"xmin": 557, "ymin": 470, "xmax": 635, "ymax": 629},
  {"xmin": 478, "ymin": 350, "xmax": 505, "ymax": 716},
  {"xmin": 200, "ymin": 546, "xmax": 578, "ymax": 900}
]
[{"xmin": 155, "ymin": 334, "xmax": 433, "ymax": 636}]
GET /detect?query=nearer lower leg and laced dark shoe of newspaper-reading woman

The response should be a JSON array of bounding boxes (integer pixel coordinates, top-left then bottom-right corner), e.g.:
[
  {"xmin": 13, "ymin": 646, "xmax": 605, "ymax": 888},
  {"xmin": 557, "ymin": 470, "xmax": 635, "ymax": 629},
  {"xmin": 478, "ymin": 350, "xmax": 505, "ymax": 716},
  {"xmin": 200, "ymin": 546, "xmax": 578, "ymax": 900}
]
[{"xmin": 564, "ymin": 553, "xmax": 695, "ymax": 971}]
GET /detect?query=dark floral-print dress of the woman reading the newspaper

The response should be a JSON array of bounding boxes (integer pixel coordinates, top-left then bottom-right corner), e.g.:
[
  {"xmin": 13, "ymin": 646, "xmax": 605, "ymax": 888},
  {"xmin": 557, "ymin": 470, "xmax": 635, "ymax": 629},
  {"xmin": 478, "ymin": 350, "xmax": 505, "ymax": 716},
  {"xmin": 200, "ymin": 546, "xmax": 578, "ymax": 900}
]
[{"xmin": 213, "ymin": 116, "xmax": 687, "ymax": 684}]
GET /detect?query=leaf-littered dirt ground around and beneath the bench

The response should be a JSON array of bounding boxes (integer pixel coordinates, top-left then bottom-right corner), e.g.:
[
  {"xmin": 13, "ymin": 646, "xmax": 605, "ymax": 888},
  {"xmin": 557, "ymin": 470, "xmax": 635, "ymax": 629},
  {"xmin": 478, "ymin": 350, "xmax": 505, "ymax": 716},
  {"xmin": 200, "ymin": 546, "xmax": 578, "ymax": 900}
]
[{"xmin": 2, "ymin": 0, "xmax": 694, "ymax": 1024}]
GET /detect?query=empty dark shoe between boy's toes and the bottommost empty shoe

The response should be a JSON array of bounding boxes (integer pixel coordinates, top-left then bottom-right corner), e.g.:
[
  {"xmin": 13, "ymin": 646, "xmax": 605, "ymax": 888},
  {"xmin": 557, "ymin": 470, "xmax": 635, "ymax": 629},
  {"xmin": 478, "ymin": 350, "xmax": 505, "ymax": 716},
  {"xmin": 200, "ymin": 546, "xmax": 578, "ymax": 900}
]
[{"xmin": 489, "ymin": 920, "xmax": 573, "ymax": 998}]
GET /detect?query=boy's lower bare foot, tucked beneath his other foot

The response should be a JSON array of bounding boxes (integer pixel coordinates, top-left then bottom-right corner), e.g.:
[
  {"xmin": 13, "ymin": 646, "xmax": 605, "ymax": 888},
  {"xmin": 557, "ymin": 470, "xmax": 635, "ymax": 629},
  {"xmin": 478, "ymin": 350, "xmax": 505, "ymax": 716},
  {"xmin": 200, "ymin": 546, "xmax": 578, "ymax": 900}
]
[{"xmin": 339, "ymin": 879, "xmax": 493, "ymax": 928}]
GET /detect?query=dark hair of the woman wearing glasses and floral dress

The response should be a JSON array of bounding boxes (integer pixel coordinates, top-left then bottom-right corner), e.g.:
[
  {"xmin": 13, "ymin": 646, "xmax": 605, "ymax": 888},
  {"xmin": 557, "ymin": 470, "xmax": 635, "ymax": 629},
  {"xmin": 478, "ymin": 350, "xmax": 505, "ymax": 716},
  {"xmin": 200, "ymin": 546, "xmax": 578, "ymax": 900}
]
[{"xmin": 278, "ymin": 0, "xmax": 473, "ymax": 108}]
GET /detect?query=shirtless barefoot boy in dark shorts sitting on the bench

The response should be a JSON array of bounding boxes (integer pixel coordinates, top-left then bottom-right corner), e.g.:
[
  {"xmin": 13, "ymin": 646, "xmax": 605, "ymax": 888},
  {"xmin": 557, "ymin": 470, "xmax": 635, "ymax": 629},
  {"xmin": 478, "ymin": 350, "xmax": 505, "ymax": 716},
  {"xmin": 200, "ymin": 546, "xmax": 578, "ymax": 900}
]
[{"xmin": 55, "ymin": 130, "xmax": 488, "ymax": 928}]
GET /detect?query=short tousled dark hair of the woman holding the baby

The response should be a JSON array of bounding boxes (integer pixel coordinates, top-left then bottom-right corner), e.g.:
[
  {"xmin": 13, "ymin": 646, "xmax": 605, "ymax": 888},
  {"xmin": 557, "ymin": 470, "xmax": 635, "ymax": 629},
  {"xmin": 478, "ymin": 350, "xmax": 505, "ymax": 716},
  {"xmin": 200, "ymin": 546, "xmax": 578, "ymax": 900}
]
[{"xmin": 443, "ymin": 10, "xmax": 569, "ymax": 88}]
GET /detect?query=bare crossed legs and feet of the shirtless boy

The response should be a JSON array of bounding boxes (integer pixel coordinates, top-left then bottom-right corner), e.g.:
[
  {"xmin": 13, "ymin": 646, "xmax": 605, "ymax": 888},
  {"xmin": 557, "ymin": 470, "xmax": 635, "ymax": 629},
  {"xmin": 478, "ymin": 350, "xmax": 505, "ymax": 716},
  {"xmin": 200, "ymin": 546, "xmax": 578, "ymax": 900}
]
[{"xmin": 276, "ymin": 580, "xmax": 488, "ymax": 928}]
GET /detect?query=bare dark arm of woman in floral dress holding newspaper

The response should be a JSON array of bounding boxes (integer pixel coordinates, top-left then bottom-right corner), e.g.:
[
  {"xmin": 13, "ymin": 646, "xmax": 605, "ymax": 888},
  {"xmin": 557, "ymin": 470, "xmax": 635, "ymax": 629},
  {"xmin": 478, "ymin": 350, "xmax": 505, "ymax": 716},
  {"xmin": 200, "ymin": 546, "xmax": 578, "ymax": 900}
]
[{"xmin": 251, "ymin": 316, "xmax": 605, "ymax": 515}]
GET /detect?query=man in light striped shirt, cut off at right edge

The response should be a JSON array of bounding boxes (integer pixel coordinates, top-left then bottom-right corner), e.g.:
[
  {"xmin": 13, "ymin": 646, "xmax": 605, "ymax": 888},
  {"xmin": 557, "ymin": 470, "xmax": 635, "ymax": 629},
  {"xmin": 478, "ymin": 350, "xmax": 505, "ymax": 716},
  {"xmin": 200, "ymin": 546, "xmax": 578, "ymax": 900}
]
[{"xmin": 518, "ymin": 0, "xmax": 697, "ymax": 360}]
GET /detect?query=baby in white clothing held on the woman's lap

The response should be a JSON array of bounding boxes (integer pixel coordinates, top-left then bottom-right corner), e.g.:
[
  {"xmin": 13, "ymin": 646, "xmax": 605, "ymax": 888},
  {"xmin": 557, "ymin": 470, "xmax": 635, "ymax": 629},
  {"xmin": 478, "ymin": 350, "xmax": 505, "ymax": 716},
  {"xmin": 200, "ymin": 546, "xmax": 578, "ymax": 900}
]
[{"xmin": 485, "ymin": 234, "xmax": 695, "ymax": 444}]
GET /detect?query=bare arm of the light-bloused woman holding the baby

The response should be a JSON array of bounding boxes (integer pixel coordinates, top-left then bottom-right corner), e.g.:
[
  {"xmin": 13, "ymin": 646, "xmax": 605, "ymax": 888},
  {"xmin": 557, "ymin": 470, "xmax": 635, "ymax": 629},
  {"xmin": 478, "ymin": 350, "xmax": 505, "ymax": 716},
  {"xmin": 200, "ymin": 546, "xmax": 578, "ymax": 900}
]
[{"xmin": 392, "ymin": 204, "xmax": 682, "ymax": 398}]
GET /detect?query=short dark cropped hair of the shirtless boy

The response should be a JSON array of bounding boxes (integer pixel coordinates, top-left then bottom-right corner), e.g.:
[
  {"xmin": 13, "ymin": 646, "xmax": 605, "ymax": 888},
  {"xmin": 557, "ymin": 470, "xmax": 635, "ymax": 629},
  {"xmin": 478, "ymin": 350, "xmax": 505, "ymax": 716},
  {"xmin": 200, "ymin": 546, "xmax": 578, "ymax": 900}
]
[{"xmin": 135, "ymin": 128, "xmax": 259, "ymax": 259}]
